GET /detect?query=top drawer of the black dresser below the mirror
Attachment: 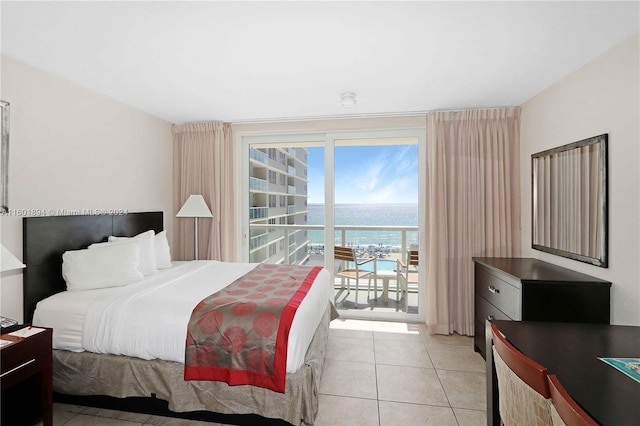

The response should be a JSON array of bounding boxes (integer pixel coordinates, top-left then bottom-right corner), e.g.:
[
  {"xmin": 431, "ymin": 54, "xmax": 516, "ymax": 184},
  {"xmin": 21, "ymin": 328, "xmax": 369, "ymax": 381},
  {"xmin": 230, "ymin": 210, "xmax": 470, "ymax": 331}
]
[{"xmin": 475, "ymin": 266, "xmax": 522, "ymax": 320}]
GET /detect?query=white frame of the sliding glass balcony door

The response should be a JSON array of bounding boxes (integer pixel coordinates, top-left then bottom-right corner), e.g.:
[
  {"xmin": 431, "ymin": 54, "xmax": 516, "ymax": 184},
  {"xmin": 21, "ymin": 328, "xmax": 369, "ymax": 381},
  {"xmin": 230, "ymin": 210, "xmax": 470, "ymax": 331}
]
[{"xmin": 239, "ymin": 127, "xmax": 426, "ymax": 323}]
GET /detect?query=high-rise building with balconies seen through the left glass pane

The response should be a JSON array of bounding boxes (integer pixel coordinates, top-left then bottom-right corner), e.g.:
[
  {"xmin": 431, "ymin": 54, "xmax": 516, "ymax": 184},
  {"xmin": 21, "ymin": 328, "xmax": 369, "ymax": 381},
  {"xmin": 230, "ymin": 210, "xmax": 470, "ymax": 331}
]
[{"xmin": 249, "ymin": 147, "xmax": 309, "ymax": 264}]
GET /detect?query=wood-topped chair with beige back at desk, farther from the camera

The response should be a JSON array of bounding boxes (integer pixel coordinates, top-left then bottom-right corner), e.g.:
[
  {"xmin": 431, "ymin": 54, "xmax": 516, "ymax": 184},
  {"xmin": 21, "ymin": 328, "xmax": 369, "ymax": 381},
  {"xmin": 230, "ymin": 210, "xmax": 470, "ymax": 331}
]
[{"xmin": 491, "ymin": 324, "xmax": 552, "ymax": 426}]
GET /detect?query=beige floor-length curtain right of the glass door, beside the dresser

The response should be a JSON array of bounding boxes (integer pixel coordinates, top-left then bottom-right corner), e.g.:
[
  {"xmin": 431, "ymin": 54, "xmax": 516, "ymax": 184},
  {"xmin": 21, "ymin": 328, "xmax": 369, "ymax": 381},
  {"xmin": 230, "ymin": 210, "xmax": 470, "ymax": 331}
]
[{"xmin": 425, "ymin": 108, "xmax": 520, "ymax": 335}]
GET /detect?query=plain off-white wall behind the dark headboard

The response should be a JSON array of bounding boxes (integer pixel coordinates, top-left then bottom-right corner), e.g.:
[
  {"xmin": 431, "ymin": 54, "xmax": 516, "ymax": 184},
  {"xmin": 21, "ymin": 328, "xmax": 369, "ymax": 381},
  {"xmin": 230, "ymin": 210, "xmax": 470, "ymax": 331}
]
[{"xmin": 0, "ymin": 56, "xmax": 173, "ymax": 320}]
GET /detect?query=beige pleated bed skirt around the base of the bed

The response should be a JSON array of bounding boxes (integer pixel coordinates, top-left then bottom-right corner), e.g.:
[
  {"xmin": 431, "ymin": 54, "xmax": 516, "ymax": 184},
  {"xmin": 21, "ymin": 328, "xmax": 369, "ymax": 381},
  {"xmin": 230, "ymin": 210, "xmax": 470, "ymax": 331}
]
[{"xmin": 53, "ymin": 303, "xmax": 337, "ymax": 425}]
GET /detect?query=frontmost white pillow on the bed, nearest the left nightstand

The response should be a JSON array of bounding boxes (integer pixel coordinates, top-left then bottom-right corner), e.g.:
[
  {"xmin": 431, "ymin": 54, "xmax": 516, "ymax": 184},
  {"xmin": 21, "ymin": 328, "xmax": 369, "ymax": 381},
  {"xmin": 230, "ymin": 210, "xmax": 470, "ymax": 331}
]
[{"xmin": 62, "ymin": 241, "xmax": 143, "ymax": 291}]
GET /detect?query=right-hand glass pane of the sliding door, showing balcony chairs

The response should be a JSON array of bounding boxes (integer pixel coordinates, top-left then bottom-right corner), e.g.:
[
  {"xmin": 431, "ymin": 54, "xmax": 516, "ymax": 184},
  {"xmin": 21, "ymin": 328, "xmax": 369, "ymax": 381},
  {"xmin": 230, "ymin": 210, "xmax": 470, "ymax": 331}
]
[{"xmin": 333, "ymin": 138, "xmax": 419, "ymax": 315}]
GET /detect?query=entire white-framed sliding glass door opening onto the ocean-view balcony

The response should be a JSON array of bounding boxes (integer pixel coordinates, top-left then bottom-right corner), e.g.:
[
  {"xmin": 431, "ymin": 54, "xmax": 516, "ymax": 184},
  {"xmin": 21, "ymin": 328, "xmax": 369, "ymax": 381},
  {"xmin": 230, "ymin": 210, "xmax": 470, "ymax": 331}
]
[{"xmin": 242, "ymin": 129, "xmax": 424, "ymax": 321}]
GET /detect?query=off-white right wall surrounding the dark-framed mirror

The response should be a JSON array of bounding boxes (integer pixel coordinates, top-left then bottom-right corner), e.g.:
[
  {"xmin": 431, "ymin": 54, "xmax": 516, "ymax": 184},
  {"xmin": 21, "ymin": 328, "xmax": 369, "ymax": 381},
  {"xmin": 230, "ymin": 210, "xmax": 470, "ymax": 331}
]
[{"xmin": 520, "ymin": 34, "xmax": 640, "ymax": 325}]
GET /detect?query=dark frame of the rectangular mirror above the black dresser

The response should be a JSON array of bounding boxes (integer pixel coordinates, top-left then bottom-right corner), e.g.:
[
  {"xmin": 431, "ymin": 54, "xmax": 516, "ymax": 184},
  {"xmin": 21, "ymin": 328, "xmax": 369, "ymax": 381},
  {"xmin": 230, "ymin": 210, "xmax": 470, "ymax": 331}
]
[{"xmin": 531, "ymin": 134, "xmax": 609, "ymax": 268}]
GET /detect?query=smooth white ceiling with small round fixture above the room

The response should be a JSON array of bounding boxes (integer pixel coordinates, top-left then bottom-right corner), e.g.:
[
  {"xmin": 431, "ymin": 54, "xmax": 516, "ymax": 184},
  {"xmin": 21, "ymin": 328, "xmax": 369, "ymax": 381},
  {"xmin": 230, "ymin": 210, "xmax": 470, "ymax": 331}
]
[{"xmin": 0, "ymin": 1, "xmax": 640, "ymax": 123}]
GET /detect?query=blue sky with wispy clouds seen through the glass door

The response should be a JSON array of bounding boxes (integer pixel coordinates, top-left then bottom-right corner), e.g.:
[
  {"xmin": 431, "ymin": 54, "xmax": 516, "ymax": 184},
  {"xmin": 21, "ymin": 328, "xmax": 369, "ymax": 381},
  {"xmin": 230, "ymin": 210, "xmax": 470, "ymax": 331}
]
[{"xmin": 307, "ymin": 145, "xmax": 418, "ymax": 204}]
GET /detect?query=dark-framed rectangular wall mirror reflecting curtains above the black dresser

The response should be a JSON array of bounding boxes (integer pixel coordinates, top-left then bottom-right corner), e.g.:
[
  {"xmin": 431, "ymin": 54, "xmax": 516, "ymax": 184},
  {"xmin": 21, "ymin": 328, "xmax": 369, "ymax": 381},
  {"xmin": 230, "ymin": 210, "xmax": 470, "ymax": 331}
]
[{"xmin": 531, "ymin": 134, "xmax": 608, "ymax": 268}]
